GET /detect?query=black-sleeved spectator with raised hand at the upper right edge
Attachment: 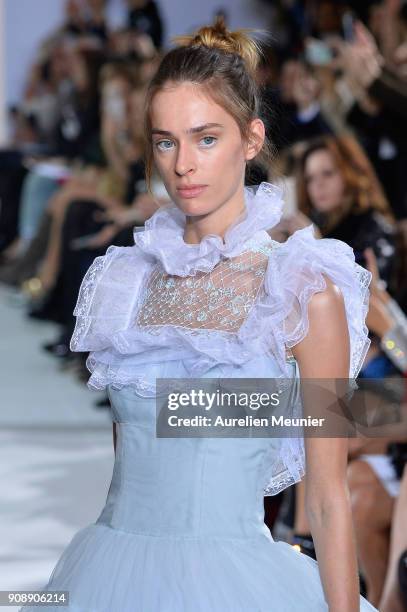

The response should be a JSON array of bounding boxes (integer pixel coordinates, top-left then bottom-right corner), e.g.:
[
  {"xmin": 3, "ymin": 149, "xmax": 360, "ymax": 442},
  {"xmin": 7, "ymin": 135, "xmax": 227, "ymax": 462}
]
[{"xmin": 338, "ymin": 22, "xmax": 407, "ymax": 219}]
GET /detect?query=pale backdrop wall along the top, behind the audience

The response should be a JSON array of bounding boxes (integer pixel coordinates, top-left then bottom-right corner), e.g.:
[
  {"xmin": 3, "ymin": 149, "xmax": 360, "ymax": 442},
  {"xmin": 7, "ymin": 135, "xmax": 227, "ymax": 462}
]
[{"xmin": 0, "ymin": 0, "xmax": 274, "ymax": 104}]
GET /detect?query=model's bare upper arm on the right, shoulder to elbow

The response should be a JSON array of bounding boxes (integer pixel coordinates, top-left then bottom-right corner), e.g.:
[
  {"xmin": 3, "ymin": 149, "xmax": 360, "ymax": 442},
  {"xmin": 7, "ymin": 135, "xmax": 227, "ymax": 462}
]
[{"xmin": 292, "ymin": 277, "xmax": 350, "ymax": 508}]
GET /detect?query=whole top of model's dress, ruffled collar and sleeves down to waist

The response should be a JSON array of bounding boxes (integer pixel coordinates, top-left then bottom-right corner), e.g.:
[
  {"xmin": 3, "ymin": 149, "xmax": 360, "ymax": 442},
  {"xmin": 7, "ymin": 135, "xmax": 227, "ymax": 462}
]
[{"xmin": 71, "ymin": 183, "xmax": 371, "ymax": 502}]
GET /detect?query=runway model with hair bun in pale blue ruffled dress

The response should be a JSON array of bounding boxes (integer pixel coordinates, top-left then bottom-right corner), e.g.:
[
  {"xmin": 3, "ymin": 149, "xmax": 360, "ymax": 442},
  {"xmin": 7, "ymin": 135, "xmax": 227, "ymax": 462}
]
[{"xmin": 24, "ymin": 19, "xmax": 375, "ymax": 612}]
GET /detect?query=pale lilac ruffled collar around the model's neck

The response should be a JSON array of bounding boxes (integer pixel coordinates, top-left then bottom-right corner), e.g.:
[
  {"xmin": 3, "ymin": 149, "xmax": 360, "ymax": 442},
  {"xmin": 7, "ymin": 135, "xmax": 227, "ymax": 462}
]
[{"xmin": 134, "ymin": 182, "xmax": 283, "ymax": 276}]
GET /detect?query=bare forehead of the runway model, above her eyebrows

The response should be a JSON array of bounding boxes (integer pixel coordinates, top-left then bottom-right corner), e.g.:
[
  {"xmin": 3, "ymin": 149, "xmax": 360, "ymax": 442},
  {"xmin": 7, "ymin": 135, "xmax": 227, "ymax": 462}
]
[{"xmin": 150, "ymin": 83, "xmax": 237, "ymax": 131}]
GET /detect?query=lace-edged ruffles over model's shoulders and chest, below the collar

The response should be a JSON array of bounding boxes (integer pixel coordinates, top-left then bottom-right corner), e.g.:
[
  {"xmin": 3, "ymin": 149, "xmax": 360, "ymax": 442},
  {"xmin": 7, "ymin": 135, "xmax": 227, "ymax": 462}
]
[{"xmin": 71, "ymin": 225, "xmax": 371, "ymax": 392}]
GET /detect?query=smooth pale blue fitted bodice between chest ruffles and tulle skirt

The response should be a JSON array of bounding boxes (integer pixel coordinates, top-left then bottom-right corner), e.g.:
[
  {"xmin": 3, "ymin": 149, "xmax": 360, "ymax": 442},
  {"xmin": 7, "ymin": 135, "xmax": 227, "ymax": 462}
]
[{"xmin": 98, "ymin": 359, "xmax": 295, "ymax": 538}]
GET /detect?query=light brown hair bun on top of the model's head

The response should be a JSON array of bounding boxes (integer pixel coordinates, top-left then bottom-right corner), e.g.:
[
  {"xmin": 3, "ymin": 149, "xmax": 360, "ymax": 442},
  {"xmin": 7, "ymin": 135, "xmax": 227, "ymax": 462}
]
[{"xmin": 173, "ymin": 15, "xmax": 261, "ymax": 73}]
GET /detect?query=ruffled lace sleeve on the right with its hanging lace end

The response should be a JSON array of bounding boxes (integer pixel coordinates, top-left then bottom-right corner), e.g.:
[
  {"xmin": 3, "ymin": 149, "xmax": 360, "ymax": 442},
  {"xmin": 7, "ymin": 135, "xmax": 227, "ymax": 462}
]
[{"xmin": 255, "ymin": 225, "xmax": 372, "ymax": 495}]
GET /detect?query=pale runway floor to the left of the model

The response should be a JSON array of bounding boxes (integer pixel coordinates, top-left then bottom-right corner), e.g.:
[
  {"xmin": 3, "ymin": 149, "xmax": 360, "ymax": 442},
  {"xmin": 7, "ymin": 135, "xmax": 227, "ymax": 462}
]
[{"xmin": 0, "ymin": 289, "xmax": 114, "ymax": 611}]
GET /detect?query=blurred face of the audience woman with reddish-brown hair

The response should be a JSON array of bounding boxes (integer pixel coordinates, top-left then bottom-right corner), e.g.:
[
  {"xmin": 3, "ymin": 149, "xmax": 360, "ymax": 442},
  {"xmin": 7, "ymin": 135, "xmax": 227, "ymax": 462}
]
[{"xmin": 305, "ymin": 149, "xmax": 345, "ymax": 212}]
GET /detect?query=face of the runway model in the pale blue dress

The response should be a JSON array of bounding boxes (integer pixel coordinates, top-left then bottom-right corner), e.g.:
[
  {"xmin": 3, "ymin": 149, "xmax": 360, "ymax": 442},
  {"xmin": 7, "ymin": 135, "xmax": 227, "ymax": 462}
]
[{"xmin": 150, "ymin": 83, "xmax": 264, "ymax": 216}]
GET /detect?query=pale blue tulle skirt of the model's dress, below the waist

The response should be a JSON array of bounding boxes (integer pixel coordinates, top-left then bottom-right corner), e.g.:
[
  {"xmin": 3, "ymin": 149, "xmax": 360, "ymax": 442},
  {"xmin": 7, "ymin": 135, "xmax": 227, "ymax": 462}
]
[{"xmin": 20, "ymin": 523, "xmax": 375, "ymax": 612}]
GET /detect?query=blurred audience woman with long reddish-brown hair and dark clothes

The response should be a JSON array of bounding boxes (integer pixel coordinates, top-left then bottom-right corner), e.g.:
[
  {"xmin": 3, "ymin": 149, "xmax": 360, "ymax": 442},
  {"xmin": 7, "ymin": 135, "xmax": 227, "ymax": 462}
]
[{"xmin": 297, "ymin": 135, "xmax": 396, "ymax": 282}]
